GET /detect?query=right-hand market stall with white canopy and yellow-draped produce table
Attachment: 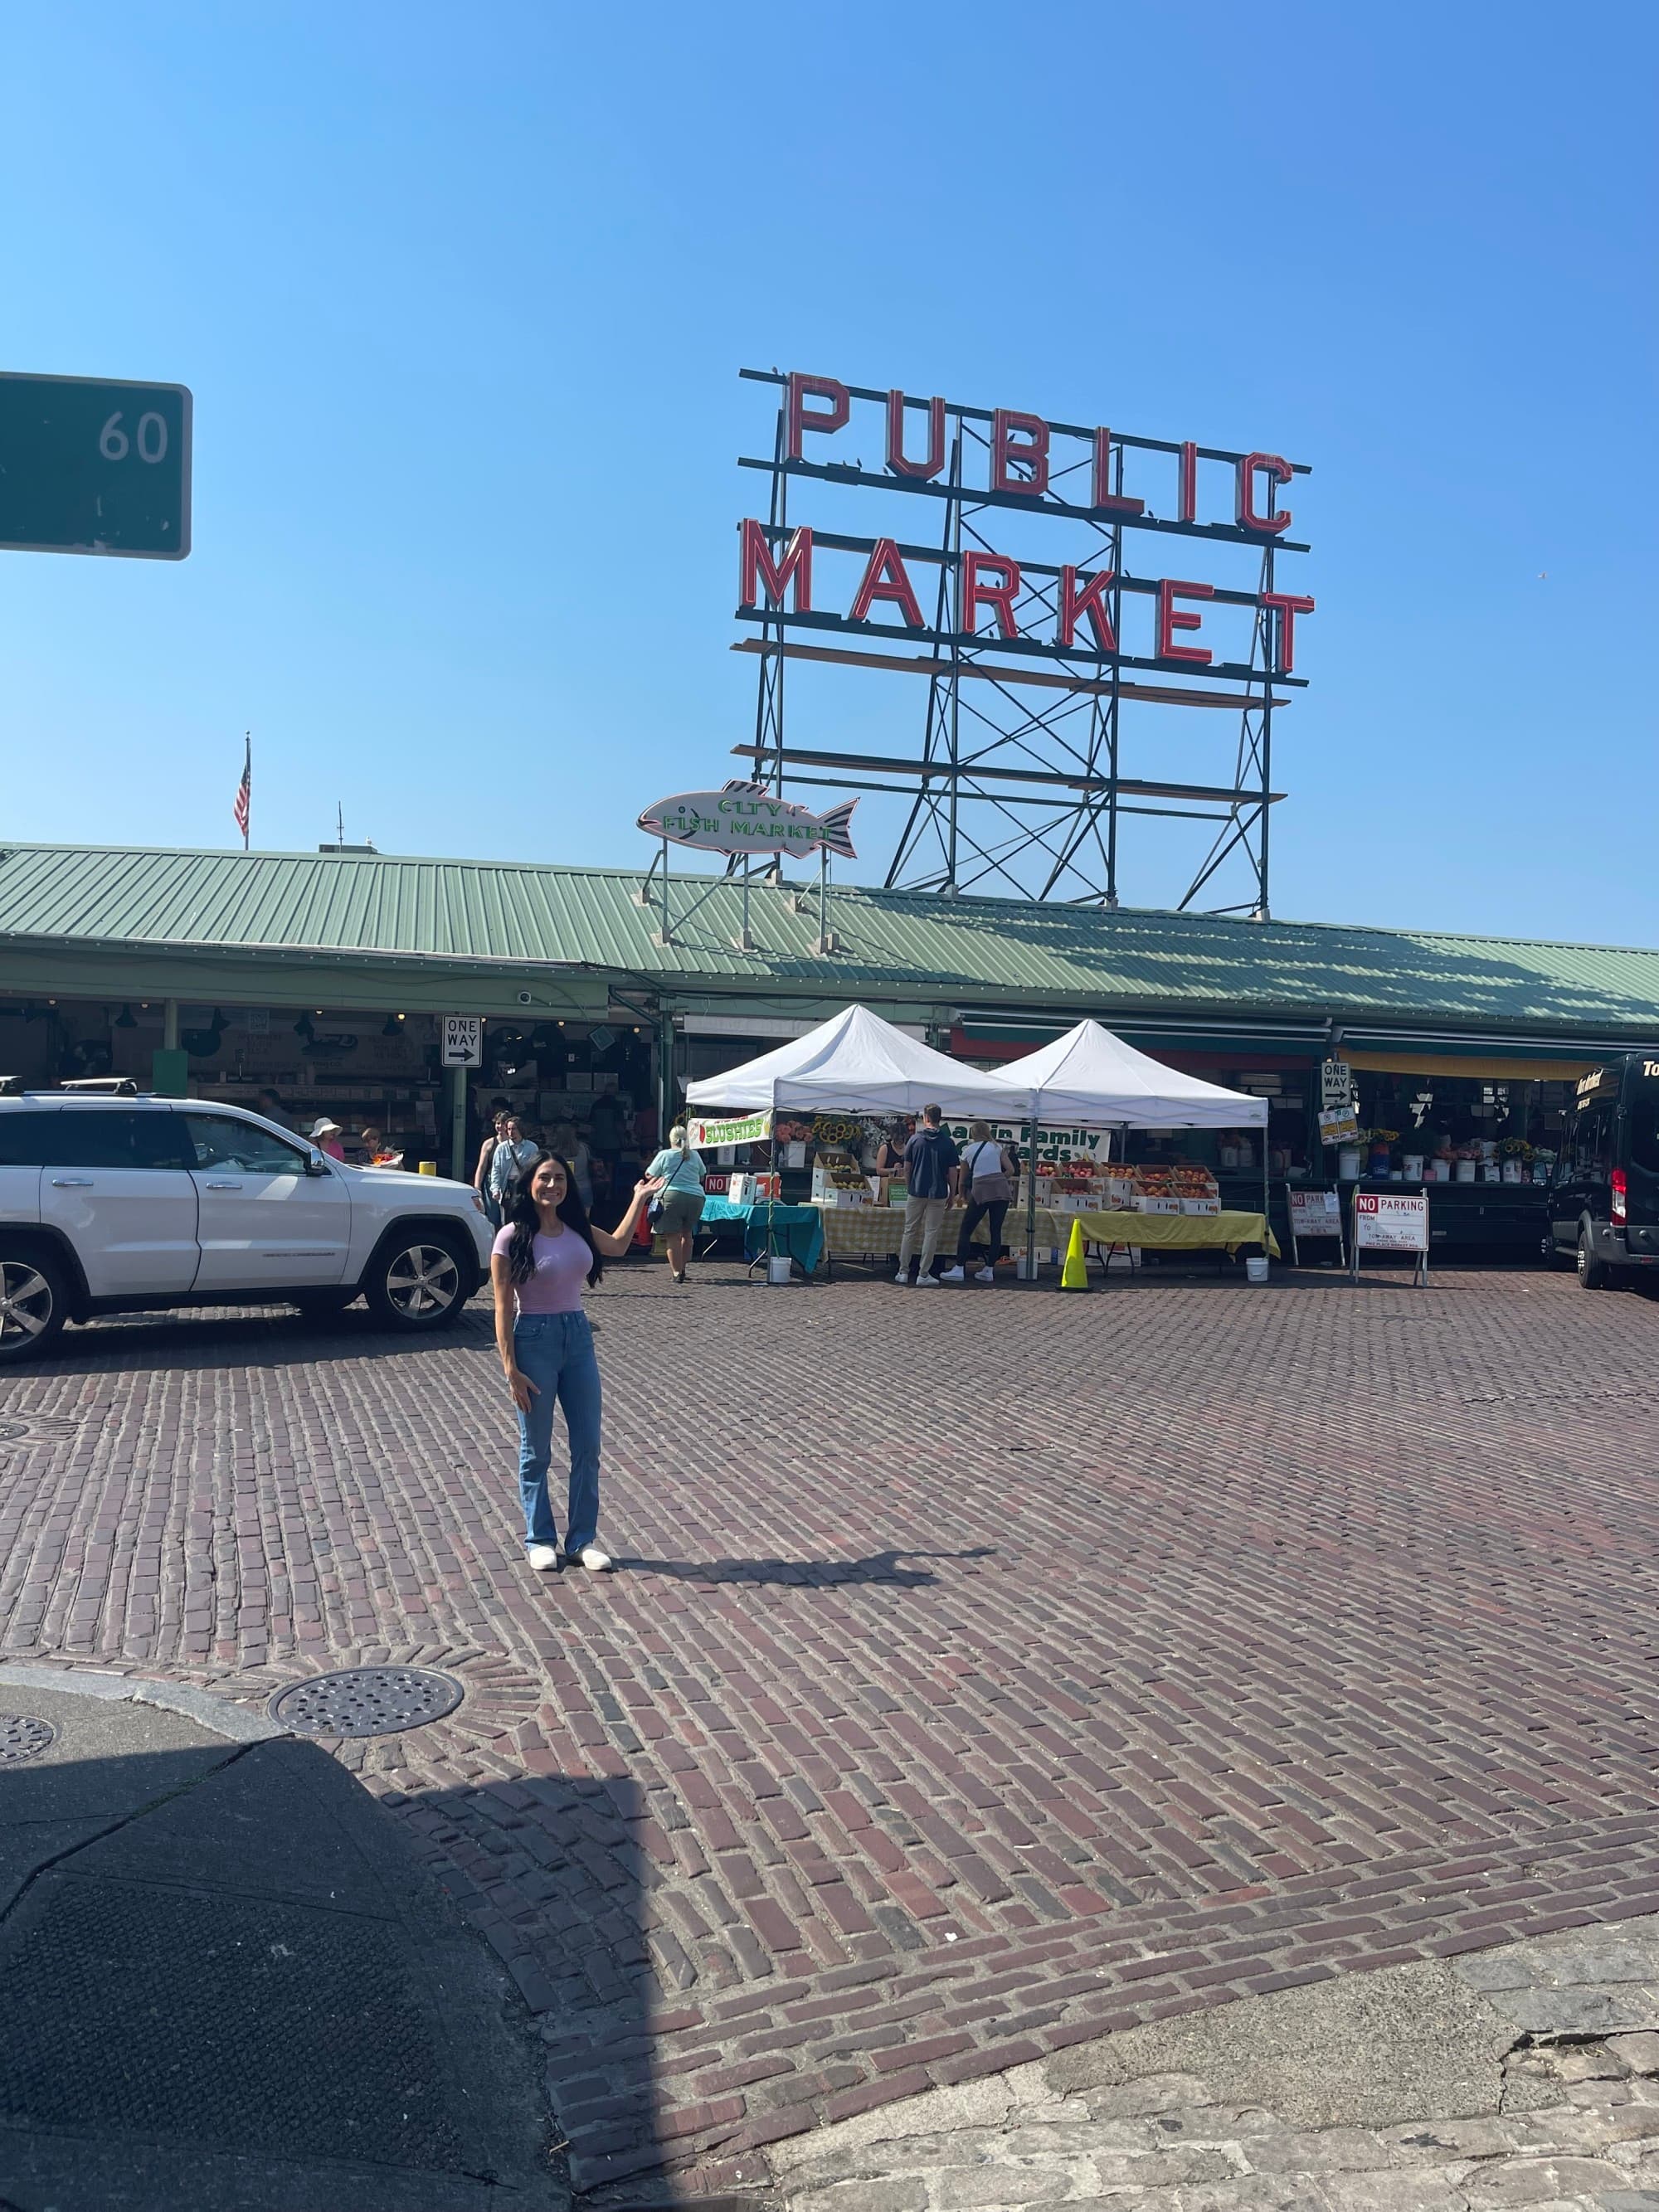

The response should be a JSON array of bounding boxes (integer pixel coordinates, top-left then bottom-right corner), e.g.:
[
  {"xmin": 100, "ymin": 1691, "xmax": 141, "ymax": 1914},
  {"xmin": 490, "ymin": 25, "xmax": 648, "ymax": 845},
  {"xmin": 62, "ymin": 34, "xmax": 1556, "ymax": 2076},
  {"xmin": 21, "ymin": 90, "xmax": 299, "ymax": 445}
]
[{"xmin": 991, "ymin": 1022, "xmax": 1278, "ymax": 1272}]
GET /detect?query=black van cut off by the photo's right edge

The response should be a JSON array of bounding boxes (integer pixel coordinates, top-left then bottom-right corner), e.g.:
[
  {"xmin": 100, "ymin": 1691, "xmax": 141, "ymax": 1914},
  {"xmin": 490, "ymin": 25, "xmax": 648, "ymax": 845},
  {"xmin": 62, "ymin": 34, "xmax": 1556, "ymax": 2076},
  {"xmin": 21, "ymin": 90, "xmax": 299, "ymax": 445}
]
[{"xmin": 1549, "ymin": 1053, "xmax": 1659, "ymax": 1290}]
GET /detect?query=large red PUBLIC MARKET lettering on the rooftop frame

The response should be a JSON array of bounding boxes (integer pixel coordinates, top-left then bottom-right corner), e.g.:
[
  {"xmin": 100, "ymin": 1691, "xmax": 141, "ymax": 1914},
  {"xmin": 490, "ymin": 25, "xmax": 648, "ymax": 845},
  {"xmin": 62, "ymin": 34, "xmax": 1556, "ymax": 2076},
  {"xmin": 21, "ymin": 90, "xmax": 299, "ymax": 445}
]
[{"xmin": 737, "ymin": 369, "xmax": 1314, "ymax": 679}]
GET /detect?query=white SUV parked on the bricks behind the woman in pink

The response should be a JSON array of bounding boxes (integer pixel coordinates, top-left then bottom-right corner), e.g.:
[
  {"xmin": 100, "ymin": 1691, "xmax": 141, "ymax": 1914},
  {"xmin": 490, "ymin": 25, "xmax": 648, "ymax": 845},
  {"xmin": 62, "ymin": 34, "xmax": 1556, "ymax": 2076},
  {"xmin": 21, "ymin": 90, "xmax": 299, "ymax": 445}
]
[{"xmin": 0, "ymin": 1091, "xmax": 491, "ymax": 1365}]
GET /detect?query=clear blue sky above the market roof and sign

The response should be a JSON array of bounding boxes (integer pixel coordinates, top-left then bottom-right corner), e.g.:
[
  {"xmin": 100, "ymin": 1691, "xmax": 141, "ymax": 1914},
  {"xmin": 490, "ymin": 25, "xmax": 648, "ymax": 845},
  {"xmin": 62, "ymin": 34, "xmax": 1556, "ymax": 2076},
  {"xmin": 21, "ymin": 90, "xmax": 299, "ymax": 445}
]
[{"xmin": 0, "ymin": 0, "xmax": 1659, "ymax": 945}]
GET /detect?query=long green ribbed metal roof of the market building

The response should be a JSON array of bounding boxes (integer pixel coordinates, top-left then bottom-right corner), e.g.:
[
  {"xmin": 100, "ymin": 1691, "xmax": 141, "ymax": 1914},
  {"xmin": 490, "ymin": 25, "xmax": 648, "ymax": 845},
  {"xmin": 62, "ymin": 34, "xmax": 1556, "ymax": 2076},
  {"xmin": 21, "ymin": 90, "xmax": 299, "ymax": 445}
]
[{"xmin": 0, "ymin": 845, "xmax": 1659, "ymax": 1039}]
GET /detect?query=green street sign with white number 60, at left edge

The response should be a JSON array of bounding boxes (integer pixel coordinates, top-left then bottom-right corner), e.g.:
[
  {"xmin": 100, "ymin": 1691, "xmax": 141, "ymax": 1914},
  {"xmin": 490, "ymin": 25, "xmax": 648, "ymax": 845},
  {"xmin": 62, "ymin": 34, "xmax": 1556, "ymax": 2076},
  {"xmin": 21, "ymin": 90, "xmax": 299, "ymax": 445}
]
[{"xmin": 0, "ymin": 369, "xmax": 190, "ymax": 560}]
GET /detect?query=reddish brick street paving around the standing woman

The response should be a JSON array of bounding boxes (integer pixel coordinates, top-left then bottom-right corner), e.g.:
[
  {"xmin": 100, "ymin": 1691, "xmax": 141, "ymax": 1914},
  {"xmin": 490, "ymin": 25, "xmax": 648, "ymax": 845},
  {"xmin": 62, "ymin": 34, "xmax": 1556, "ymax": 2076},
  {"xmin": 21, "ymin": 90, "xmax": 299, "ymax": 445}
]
[{"xmin": 0, "ymin": 1267, "xmax": 1659, "ymax": 2203}]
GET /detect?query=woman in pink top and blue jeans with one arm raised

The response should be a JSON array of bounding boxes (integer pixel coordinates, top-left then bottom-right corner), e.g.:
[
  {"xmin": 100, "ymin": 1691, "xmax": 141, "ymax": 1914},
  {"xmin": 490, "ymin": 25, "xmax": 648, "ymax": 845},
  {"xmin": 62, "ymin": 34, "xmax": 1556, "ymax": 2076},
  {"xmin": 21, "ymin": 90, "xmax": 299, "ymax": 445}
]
[{"xmin": 489, "ymin": 1157, "xmax": 659, "ymax": 1573}]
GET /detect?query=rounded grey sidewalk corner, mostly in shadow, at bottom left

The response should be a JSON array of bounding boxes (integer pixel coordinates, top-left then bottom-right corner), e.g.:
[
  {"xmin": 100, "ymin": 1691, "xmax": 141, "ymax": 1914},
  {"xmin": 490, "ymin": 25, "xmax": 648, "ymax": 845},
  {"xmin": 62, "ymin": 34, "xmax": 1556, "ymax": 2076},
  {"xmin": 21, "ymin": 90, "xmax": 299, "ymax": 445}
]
[{"xmin": 0, "ymin": 1681, "xmax": 571, "ymax": 2212}]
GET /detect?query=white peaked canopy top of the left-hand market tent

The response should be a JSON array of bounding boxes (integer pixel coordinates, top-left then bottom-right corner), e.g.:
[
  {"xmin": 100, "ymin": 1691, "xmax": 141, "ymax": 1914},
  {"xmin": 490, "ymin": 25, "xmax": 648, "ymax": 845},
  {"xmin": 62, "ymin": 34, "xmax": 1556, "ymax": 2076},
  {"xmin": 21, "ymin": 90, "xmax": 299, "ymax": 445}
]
[{"xmin": 686, "ymin": 1006, "xmax": 1009, "ymax": 1120}]
